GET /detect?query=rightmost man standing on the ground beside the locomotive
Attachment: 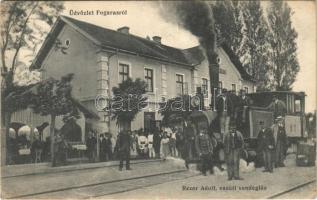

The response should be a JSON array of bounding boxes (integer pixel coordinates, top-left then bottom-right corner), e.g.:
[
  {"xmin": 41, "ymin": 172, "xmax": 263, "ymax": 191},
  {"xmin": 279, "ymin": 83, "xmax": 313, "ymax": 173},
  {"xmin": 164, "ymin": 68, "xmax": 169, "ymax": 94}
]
[{"xmin": 273, "ymin": 117, "xmax": 287, "ymax": 167}]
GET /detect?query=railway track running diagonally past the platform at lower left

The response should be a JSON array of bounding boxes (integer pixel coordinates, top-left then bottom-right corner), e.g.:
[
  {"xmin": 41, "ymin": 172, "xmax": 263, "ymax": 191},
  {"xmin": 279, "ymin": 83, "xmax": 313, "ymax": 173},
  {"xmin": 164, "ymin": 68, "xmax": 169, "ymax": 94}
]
[{"xmin": 8, "ymin": 170, "xmax": 197, "ymax": 199}]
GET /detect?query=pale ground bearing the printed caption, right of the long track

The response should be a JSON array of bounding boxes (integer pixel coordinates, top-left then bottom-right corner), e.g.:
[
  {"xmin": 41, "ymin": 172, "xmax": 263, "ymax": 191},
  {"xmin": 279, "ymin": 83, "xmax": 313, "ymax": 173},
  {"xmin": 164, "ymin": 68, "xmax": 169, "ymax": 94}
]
[{"xmin": 105, "ymin": 154, "xmax": 317, "ymax": 199}]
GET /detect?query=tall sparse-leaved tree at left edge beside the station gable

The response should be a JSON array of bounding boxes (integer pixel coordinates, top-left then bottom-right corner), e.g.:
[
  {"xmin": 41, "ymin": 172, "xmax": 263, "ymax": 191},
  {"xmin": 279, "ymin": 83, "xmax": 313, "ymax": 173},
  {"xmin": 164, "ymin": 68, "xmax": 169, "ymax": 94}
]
[{"xmin": 0, "ymin": 1, "xmax": 63, "ymax": 164}]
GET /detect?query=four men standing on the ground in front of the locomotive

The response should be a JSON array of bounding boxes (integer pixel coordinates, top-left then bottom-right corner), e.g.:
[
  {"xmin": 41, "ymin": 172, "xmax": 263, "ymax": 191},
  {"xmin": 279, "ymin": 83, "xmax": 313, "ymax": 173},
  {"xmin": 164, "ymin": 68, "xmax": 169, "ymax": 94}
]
[{"xmin": 195, "ymin": 117, "xmax": 288, "ymax": 180}]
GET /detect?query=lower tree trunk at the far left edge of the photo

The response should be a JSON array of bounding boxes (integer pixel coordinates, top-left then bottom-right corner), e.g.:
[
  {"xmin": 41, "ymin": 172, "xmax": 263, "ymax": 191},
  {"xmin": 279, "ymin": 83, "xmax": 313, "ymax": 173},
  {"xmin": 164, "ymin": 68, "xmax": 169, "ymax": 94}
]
[{"xmin": 1, "ymin": 112, "xmax": 12, "ymax": 166}]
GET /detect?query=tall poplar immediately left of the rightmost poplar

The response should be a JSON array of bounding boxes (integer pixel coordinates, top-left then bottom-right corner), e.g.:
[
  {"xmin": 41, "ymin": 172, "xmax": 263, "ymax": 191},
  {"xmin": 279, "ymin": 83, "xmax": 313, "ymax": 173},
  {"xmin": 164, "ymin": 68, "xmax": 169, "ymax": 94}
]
[{"xmin": 240, "ymin": 1, "xmax": 269, "ymax": 90}]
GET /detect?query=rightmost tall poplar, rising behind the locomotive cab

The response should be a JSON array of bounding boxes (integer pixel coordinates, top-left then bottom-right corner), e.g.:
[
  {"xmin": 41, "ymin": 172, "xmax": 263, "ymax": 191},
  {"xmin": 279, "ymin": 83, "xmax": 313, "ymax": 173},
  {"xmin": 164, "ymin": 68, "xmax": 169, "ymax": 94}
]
[{"xmin": 267, "ymin": 1, "xmax": 299, "ymax": 90}]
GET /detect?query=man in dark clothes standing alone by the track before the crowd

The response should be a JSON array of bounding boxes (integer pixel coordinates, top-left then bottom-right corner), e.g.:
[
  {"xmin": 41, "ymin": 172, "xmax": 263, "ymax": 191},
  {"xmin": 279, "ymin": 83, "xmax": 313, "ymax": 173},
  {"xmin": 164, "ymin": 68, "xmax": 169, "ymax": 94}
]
[{"xmin": 116, "ymin": 131, "xmax": 132, "ymax": 171}]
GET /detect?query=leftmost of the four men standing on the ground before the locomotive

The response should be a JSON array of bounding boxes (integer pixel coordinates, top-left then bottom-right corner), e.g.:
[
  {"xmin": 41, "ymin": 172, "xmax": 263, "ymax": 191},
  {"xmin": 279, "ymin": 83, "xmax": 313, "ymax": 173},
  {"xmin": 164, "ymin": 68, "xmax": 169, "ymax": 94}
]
[{"xmin": 195, "ymin": 128, "xmax": 214, "ymax": 176}]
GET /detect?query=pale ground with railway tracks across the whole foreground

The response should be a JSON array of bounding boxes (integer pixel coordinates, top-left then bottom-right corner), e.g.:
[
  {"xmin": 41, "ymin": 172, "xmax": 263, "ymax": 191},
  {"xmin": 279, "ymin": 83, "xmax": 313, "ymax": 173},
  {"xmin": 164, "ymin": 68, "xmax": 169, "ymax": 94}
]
[{"xmin": 1, "ymin": 154, "xmax": 316, "ymax": 199}]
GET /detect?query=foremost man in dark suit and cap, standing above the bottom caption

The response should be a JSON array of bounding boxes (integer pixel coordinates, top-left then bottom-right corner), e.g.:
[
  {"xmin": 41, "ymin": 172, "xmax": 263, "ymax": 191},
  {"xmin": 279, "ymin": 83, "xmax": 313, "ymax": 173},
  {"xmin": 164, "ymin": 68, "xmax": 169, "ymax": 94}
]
[{"xmin": 224, "ymin": 121, "xmax": 244, "ymax": 181}]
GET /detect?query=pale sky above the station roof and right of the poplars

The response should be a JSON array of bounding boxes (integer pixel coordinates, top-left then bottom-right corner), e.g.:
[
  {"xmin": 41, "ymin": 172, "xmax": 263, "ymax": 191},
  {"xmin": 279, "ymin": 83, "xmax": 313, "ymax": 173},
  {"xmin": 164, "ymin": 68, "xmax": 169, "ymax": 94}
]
[{"xmin": 45, "ymin": 1, "xmax": 317, "ymax": 112}]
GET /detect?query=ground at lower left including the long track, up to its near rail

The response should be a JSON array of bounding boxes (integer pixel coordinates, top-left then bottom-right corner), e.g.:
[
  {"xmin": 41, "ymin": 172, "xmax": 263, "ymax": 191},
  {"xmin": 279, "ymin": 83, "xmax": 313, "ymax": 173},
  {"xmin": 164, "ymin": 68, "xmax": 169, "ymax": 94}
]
[{"xmin": 1, "ymin": 157, "xmax": 191, "ymax": 199}]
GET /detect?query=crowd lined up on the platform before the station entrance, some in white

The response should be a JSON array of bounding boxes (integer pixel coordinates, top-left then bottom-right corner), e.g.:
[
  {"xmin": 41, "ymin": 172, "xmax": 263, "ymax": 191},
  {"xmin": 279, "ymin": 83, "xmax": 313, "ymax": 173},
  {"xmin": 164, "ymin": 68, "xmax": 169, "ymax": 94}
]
[{"xmin": 82, "ymin": 128, "xmax": 188, "ymax": 169}]
